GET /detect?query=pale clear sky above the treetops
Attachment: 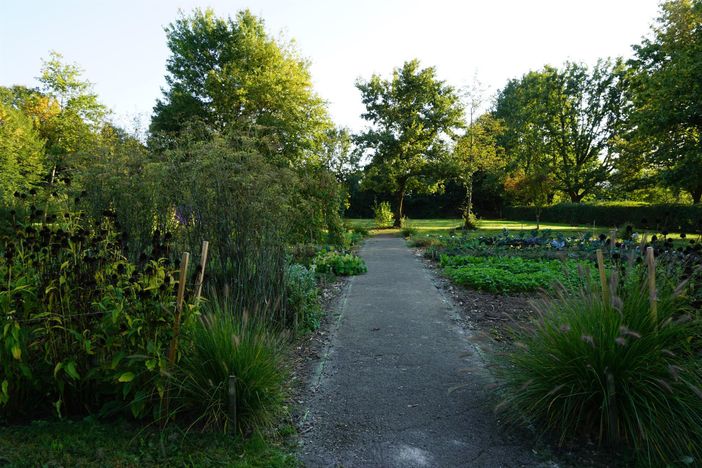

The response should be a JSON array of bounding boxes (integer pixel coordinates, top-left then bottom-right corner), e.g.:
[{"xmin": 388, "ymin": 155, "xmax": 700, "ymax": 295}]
[{"xmin": 0, "ymin": 0, "xmax": 658, "ymax": 129}]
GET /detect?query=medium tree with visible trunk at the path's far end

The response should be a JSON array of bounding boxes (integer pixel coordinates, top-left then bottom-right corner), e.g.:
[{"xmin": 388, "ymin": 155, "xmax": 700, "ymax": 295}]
[{"xmin": 355, "ymin": 60, "xmax": 463, "ymax": 227}]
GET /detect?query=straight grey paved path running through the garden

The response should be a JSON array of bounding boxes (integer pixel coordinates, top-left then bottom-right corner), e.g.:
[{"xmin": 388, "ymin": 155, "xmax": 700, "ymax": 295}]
[{"xmin": 300, "ymin": 236, "xmax": 539, "ymax": 467}]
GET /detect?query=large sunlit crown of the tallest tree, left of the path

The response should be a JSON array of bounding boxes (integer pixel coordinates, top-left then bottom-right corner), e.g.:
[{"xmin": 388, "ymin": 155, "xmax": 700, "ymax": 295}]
[{"xmin": 151, "ymin": 9, "xmax": 330, "ymax": 164}]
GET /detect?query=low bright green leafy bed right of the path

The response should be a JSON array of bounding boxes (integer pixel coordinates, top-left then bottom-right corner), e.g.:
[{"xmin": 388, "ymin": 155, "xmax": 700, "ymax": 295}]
[{"xmin": 440, "ymin": 255, "xmax": 579, "ymax": 293}]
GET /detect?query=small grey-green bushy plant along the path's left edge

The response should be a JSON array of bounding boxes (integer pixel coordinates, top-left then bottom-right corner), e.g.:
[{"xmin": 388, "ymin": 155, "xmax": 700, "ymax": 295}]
[{"xmin": 285, "ymin": 264, "xmax": 322, "ymax": 331}]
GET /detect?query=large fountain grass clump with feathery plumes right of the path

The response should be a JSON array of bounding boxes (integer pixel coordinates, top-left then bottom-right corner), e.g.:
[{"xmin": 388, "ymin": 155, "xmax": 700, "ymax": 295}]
[{"xmin": 496, "ymin": 264, "xmax": 702, "ymax": 466}]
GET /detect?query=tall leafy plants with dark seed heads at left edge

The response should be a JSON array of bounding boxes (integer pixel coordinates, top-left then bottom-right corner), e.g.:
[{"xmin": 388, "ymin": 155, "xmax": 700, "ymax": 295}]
[{"xmin": 0, "ymin": 208, "xmax": 183, "ymax": 418}]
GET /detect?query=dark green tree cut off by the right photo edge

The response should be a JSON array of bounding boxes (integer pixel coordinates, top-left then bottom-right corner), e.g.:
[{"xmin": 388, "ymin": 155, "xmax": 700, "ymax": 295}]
[{"xmin": 627, "ymin": 0, "xmax": 702, "ymax": 203}]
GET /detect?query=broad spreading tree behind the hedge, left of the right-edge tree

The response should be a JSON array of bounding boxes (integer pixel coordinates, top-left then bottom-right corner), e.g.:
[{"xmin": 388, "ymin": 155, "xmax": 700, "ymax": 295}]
[{"xmin": 495, "ymin": 61, "xmax": 624, "ymax": 202}]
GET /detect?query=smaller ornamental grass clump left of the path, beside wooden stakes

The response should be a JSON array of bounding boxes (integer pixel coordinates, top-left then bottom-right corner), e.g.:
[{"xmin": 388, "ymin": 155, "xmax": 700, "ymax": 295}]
[{"xmin": 173, "ymin": 298, "xmax": 287, "ymax": 432}]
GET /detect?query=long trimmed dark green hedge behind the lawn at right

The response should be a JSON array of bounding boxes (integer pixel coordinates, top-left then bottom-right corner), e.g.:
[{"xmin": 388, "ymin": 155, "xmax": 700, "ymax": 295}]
[{"xmin": 504, "ymin": 203, "xmax": 702, "ymax": 233}]
